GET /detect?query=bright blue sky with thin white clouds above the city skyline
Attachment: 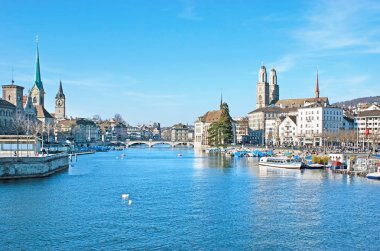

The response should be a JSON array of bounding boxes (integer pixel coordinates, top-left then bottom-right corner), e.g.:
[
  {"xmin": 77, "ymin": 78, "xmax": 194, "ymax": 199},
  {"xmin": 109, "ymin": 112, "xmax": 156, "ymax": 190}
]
[{"xmin": 0, "ymin": 0, "xmax": 380, "ymax": 125}]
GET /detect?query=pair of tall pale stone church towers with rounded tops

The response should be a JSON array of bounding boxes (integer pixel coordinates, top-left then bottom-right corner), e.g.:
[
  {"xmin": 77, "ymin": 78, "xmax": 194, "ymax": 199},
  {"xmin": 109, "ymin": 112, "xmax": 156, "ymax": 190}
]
[{"xmin": 256, "ymin": 65, "xmax": 280, "ymax": 109}]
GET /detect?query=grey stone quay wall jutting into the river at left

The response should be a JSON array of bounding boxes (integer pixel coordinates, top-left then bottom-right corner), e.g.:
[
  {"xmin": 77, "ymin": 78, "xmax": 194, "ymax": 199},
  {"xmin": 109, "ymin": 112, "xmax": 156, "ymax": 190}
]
[{"xmin": 0, "ymin": 153, "xmax": 69, "ymax": 180}]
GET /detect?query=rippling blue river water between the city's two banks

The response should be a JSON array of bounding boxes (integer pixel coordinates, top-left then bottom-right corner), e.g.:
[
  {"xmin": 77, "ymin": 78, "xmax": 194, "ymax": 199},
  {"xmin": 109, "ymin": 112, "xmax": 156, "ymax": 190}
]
[{"xmin": 0, "ymin": 148, "xmax": 380, "ymax": 250}]
